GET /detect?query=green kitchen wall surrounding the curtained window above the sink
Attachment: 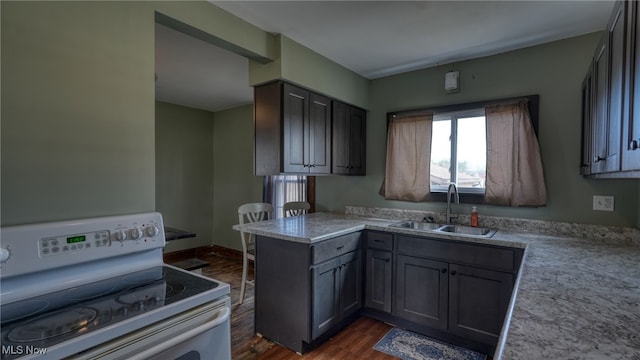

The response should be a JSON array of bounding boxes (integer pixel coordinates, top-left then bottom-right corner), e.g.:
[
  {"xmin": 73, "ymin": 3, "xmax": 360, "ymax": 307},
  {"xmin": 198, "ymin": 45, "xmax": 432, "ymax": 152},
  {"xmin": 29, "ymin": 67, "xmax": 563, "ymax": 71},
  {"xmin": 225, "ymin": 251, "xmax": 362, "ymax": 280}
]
[{"xmin": 316, "ymin": 33, "xmax": 639, "ymax": 226}]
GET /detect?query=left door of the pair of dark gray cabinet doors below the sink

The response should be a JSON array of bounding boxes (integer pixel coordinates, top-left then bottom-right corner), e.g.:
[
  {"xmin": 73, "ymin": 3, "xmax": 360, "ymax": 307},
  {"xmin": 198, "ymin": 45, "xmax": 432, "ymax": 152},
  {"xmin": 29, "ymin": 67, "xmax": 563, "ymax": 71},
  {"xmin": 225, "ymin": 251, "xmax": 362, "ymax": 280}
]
[{"xmin": 393, "ymin": 255, "xmax": 449, "ymax": 330}]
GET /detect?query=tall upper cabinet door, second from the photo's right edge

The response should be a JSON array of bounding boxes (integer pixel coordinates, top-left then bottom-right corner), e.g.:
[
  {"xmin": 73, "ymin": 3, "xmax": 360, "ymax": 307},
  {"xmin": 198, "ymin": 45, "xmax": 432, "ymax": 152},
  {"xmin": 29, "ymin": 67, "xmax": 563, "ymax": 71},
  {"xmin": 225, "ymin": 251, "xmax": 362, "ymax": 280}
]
[{"xmin": 604, "ymin": 1, "xmax": 627, "ymax": 172}]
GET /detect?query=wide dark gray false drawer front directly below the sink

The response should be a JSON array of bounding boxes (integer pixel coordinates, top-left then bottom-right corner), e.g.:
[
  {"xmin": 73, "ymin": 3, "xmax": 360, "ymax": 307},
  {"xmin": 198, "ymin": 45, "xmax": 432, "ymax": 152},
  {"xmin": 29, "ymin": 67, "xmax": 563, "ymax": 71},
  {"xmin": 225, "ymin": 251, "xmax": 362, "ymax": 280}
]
[{"xmin": 397, "ymin": 236, "xmax": 515, "ymax": 272}]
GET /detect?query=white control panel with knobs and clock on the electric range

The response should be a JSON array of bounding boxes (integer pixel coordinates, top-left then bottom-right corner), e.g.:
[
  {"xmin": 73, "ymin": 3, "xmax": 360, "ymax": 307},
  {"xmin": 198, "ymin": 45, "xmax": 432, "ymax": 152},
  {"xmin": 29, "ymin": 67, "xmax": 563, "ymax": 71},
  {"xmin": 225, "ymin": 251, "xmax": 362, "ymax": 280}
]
[{"xmin": 0, "ymin": 213, "xmax": 165, "ymax": 278}]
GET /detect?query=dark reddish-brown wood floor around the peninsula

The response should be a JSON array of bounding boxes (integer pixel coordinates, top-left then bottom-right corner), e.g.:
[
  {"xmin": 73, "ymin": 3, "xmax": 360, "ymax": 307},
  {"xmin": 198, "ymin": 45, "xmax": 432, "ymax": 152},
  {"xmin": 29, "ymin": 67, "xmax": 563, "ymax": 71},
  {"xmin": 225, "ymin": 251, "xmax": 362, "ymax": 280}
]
[{"xmin": 200, "ymin": 254, "xmax": 396, "ymax": 360}]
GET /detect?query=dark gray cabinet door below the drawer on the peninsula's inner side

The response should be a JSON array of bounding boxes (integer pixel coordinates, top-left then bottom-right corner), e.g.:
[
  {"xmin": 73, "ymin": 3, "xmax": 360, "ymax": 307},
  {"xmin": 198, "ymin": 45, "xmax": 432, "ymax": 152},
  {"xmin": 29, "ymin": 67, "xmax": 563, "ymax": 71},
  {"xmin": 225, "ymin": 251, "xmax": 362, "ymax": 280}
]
[{"xmin": 311, "ymin": 251, "xmax": 362, "ymax": 339}]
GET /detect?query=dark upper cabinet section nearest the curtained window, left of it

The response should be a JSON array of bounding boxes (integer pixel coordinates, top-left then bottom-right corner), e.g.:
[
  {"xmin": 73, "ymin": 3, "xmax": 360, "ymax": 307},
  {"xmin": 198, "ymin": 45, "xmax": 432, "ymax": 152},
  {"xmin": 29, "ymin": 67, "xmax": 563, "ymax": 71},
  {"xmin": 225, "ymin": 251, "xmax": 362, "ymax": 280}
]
[{"xmin": 332, "ymin": 101, "xmax": 366, "ymax": 175}]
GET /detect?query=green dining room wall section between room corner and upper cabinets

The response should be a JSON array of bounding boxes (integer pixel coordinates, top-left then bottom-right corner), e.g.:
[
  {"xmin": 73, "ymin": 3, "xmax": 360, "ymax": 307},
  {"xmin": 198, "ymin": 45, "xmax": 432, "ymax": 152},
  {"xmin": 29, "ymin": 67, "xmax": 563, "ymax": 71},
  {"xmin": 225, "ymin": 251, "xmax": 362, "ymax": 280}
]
[{"xmin": 213, "ymin": 104, "xmax": 262, "ymax": 250}]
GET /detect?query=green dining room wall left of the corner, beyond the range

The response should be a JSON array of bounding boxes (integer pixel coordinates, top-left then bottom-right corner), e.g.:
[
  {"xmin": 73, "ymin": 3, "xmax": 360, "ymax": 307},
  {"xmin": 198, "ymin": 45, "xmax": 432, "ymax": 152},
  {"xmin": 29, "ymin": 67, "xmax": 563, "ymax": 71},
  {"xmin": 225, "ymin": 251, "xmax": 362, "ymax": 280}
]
[{"xmin": 155, "ymin": 102, "xmax": 214, "ymax": 252}]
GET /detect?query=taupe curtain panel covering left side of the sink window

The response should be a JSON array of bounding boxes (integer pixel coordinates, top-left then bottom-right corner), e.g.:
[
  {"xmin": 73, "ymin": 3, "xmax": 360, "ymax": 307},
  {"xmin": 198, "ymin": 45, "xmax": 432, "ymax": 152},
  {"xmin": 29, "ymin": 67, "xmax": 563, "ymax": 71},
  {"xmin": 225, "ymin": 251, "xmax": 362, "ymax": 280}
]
[{"xmin": 381, "ymin": 115, "xmax": 433, "ymax": 202}]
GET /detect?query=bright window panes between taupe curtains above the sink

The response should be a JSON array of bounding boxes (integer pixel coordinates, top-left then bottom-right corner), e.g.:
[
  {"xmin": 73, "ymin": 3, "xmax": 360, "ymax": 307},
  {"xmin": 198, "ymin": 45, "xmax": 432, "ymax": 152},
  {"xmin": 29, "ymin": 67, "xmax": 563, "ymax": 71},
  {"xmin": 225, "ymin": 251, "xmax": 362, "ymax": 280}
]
[{"xmin": 430, "ymin": 108, "xmax": 487, "ymax": 194}]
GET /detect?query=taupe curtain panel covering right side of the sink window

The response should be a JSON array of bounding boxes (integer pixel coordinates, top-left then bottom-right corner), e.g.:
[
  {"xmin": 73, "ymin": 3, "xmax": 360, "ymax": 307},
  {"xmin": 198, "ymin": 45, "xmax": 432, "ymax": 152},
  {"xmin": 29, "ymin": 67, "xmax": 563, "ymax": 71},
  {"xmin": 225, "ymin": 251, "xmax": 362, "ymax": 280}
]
[{"xmin": 485, "ymin": 101, "xmax": 547, "ymax": 207}]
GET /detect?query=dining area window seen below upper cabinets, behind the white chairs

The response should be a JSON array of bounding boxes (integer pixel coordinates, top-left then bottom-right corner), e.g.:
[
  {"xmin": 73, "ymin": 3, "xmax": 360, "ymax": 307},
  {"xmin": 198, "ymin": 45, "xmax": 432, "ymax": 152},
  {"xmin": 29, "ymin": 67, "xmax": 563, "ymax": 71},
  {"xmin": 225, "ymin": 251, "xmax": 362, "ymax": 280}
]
[{"xmin": 263, "ymin": 175, "xmax": 307, "ymax": 218}]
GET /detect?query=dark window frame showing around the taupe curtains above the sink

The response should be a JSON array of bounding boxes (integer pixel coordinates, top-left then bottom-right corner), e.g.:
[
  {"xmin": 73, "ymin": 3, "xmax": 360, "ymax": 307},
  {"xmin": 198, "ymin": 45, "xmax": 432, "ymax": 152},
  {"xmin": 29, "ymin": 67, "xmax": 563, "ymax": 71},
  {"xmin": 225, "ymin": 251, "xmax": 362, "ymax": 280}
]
[{"xmin": 387, "ymin": 94, "xmax": 540, "ymax": 204}]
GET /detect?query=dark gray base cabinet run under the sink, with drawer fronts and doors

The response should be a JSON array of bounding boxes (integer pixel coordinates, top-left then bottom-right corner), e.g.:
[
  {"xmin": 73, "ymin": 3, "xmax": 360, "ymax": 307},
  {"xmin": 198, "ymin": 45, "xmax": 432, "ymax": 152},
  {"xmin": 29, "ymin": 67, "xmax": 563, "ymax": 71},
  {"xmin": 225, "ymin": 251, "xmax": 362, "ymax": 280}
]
[{"xmin": 365, "ymin": 231, "xmax": 523, "ymax": 353}]
